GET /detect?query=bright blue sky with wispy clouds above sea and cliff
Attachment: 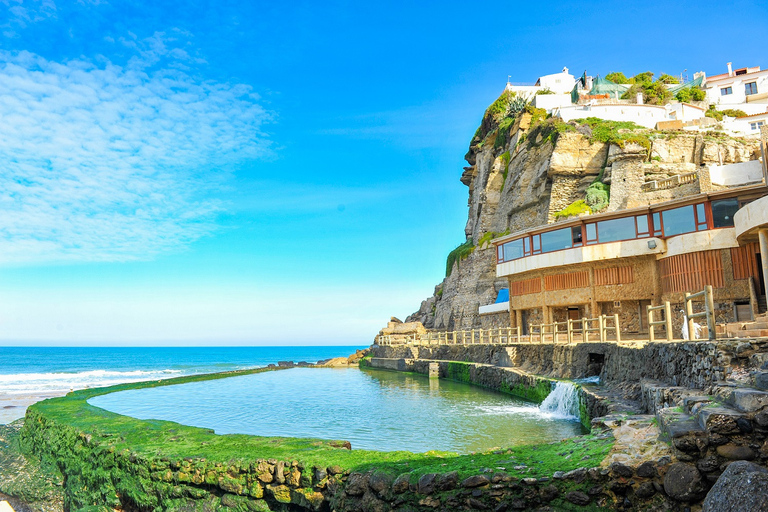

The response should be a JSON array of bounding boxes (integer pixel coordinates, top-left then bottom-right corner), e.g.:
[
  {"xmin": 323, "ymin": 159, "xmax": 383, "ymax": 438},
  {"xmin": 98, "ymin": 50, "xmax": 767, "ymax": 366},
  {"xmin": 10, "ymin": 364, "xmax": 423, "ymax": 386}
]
[{"xmin": 0, "ymin": 0, "xmax": 768, "ymax": 345}]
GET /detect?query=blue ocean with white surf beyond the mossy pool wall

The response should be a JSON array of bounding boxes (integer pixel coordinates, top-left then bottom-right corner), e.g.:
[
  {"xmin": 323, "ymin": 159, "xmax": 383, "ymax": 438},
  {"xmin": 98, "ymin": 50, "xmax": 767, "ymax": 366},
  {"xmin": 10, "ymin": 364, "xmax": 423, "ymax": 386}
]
[{"xmin": 0, "ymin": 346, "xmax": 365, "ymax": 423}]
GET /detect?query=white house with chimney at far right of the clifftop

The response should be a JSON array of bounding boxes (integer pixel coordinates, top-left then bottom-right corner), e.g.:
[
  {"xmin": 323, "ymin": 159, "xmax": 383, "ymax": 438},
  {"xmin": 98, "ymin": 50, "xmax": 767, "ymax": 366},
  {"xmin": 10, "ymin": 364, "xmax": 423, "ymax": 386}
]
[{"xmin": 704, "ymin": 62, "xmax": 768, "ymax": 109}]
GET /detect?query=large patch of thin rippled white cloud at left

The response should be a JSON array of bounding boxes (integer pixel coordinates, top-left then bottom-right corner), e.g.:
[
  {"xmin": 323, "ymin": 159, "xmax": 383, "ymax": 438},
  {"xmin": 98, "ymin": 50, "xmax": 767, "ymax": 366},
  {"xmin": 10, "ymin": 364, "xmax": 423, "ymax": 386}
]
[{"xmin": 0, "ymin": 40, "xmax": 270, "ymax": 263}]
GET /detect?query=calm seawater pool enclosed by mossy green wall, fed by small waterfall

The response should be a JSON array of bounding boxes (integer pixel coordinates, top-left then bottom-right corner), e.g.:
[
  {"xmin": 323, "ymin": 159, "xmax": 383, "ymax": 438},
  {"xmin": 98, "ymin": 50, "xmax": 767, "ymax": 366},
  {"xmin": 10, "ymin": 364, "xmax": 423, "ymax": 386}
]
[{"xmin": 88, "ymin": 368, "xmax": 583, "ymax": 452}]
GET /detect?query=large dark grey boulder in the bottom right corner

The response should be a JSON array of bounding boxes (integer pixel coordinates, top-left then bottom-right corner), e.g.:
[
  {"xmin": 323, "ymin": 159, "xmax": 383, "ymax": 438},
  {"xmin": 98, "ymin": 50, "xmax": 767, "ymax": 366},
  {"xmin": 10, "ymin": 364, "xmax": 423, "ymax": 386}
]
[{"xmin": 702, "ymin": 461, "xmax": 768, "ymax": 512}]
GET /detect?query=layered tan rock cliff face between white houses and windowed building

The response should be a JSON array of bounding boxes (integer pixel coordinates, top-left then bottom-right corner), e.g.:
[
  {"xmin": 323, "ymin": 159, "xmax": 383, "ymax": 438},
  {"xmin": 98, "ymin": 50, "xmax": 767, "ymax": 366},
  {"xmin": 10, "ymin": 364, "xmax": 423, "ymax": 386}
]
[{"xmin": 406, "ymin": 95, "xmax": 759, "ymax": 330}]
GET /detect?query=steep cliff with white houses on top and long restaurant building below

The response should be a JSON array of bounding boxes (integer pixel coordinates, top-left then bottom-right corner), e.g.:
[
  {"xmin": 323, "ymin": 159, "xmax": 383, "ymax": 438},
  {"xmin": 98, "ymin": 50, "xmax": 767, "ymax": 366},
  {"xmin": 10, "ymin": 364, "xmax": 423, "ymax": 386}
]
[{"xmin": 377, "ymin": 63, "xmax": 768, "ymax": 342}]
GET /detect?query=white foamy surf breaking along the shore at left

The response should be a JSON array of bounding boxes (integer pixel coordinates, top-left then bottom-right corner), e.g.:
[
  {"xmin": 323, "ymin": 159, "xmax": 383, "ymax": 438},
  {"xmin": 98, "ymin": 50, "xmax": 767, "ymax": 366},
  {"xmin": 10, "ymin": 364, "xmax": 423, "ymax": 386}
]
[{"xmin": 0, "ymin": 369, "xmax": 184, "ymax": 395}]
